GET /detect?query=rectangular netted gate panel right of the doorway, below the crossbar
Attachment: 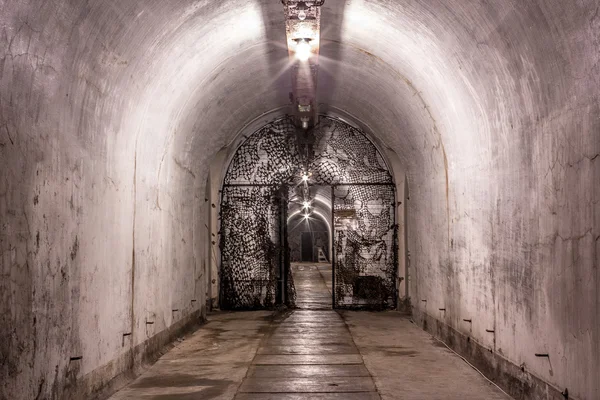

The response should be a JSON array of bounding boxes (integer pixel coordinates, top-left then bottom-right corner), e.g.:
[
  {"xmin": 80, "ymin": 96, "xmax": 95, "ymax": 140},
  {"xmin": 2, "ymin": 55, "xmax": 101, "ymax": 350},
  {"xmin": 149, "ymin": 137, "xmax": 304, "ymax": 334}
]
[{"xmin": 332, "ymin": 184, "xmax": 397, "ymax": 309}]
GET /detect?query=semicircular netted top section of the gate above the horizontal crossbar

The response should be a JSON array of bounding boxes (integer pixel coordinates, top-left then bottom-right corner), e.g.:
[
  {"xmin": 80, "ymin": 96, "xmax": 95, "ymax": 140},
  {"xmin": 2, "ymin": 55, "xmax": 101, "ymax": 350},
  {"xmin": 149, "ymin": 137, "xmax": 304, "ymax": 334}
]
[{"xmin": 225, "ymin": 117, "xmax": 393, "ymax": 186}]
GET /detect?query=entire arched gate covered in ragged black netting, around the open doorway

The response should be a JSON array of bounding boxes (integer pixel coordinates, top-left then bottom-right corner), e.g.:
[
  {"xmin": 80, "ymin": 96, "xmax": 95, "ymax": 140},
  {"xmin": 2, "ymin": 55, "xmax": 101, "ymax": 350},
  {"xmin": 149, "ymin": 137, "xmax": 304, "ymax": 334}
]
[{"xmin": 220, "ymin": 116, "xmax": 398, "ymax": 309}]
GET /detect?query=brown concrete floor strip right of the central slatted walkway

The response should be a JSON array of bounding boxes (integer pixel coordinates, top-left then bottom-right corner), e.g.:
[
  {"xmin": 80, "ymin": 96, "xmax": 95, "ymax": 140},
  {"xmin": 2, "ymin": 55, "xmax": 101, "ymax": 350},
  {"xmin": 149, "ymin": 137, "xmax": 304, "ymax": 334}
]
[{"xmin": 340, "ymin": 311, "xmax": 510, "ymax": 400}]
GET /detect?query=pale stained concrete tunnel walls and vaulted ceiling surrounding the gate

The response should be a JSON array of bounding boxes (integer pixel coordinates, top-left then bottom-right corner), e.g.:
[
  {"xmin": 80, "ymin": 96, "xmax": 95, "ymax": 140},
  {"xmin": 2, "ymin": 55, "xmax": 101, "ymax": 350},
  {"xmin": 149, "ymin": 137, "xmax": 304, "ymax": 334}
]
[{"xmin": 0, "ymin": 0, "xmax": 600, "ymax": 400}]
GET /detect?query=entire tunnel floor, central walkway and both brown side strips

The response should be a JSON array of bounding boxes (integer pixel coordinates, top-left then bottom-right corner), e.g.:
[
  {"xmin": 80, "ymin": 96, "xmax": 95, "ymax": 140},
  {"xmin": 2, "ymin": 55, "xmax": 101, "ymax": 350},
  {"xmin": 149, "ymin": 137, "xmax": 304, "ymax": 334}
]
[{"xmin": 111, "ymin": 265, "xmax": 509, "ymax": 400}]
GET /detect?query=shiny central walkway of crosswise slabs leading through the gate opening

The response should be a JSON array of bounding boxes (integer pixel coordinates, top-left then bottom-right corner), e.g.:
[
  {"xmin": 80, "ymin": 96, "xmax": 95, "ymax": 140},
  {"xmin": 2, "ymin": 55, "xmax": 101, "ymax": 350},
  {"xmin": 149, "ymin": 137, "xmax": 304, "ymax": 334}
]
[{"xmin": 236, "ymin": 266, "xmax": 379, "ymax": 399}]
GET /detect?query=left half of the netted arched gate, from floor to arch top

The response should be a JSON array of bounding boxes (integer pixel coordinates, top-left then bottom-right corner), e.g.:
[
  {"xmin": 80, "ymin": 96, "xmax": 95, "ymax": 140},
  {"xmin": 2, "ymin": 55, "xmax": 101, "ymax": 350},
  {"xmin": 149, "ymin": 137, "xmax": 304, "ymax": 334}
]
[{"xmin": 220, "ymin": 119, "xmax": 299, "ymax": 310}]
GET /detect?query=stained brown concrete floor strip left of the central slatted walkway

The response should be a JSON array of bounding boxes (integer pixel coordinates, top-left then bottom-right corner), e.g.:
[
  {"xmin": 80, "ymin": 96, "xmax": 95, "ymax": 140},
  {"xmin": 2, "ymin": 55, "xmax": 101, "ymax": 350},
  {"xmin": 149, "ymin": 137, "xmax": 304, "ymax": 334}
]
[{"xmin": 111, "ymin": 311, "xmax": 272, "ymax": 400}]
